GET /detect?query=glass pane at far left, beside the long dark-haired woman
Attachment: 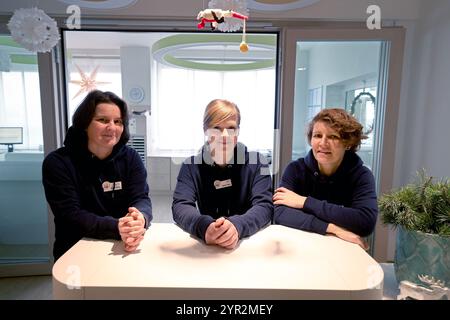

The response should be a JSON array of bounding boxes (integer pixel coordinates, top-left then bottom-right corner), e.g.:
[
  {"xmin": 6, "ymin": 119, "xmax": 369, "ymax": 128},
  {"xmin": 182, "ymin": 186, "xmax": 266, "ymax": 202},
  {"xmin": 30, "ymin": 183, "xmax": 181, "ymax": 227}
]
[{"xmin": 0, "ymin": 36, "xmax": 50, "ymax": 265}]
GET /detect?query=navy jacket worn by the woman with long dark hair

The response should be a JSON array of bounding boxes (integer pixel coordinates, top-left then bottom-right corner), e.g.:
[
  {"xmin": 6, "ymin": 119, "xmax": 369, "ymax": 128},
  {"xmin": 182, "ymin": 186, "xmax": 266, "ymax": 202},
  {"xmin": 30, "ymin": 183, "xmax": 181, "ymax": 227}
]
[{"xmin": 42, "ymin": 127, "xmax": 152, "ymax": 260}]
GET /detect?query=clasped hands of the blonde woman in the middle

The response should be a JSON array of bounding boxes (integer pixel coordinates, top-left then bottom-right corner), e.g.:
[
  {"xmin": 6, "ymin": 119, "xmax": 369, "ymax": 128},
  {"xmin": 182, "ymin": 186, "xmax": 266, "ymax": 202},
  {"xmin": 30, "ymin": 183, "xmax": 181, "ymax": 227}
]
[{"xmin": 205, "ymin": 217, "xmax": 239, "ymax": 249}]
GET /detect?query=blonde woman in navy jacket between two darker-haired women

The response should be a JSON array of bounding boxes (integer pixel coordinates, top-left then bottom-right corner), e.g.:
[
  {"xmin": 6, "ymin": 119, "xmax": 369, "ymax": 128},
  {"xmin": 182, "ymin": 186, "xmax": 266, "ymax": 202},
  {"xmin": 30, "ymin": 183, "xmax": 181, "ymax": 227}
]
[{"xmin": 172, "ymin": 99, "xmax": 273, "ymax": 249}]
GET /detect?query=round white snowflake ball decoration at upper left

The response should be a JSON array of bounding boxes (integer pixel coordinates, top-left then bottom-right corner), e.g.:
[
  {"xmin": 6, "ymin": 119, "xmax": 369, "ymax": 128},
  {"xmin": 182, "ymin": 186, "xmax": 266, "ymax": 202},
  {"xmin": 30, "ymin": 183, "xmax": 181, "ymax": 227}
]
[{"xmin": 8, "ymin": 8, "xmax": 60, "ymax": 52}]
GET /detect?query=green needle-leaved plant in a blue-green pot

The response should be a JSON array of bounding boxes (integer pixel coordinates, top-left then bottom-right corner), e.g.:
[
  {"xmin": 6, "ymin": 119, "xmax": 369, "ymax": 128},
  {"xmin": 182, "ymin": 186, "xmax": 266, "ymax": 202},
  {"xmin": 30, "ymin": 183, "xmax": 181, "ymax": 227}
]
[{"xmin": 378, "ymin": 170, "xmax": 450, "ymax": 286}]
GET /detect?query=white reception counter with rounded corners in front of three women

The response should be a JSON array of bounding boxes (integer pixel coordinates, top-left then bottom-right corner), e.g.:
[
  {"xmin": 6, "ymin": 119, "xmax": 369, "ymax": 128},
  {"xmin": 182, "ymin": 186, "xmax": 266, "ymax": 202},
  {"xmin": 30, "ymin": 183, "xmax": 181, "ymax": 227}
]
[{"xmin": 53, "ymin": 223, "xmax": 383, "ymax": 299}]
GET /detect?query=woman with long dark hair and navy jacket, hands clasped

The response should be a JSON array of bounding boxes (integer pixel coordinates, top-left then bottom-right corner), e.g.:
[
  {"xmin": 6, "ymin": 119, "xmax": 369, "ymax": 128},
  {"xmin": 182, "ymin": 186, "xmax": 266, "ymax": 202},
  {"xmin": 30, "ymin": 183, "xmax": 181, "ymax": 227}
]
[{"xmin": 42, "ymin": 90, "xmax": 152, "ymax": 261}]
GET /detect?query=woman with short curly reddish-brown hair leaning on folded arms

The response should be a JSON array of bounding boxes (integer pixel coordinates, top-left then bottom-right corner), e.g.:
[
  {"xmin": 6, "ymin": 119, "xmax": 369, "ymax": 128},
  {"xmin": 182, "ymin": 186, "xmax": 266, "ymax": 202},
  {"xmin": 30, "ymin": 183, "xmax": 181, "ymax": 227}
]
[{"xmin": 273, "ymin": 109, "xmax": 378, "ymax": 249}]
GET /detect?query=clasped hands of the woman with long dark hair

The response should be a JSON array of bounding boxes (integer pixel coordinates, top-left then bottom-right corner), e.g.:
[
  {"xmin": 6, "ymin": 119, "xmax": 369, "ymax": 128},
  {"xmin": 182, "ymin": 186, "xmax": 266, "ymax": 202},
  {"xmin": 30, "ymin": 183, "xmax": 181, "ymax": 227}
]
[{"xmin": 119, "ymin": 207, "xmax": 145, "ymax": 252}]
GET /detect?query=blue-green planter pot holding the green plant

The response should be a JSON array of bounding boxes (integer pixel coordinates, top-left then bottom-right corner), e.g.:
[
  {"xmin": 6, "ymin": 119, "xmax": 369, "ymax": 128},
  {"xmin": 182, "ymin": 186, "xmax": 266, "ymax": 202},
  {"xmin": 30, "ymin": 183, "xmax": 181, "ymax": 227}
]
[{"xmin": 394, "ymin": 227, "xmax": 450, "ymax": 287}]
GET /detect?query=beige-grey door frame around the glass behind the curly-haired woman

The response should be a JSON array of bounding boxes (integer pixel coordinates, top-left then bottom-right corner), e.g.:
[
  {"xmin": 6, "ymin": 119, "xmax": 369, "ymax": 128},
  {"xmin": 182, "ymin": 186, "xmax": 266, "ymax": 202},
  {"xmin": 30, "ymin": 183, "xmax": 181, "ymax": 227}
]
[{"xmin": 280, "ymin": 24, "xmax": 406, "ymax": 262}]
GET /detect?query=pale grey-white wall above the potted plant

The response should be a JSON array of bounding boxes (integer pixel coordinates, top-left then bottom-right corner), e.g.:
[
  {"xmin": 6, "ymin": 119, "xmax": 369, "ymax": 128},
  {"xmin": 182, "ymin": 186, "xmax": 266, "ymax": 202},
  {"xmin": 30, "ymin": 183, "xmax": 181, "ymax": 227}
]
[{"xmin": 394, "ymin": 0, "xmax": 450, "ymax": 186}]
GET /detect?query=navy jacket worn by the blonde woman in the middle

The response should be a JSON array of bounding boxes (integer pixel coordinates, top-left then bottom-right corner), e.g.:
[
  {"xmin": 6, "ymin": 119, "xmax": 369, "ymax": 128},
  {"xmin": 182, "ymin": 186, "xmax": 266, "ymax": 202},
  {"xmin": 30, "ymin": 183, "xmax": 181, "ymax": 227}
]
[{"xmin": 172, "ymin": 143, "xmax": 273, "ymax": 240}]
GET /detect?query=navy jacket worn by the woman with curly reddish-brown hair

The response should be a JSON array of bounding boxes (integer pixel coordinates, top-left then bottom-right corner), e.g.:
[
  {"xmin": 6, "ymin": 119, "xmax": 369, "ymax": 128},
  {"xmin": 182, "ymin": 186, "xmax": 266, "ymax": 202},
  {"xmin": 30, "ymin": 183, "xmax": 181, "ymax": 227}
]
[{"xmin": 274, "ymin": 151, "xmax": 378, "ymax": 237}]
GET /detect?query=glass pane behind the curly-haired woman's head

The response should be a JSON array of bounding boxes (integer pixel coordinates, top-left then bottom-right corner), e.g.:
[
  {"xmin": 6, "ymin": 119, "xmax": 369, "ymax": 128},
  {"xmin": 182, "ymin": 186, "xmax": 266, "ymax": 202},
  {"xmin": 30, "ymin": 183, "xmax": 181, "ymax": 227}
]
[{"xmin": 292, "ymin": 41, "xmax": 381, "ymax": 168}]
